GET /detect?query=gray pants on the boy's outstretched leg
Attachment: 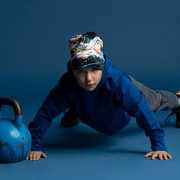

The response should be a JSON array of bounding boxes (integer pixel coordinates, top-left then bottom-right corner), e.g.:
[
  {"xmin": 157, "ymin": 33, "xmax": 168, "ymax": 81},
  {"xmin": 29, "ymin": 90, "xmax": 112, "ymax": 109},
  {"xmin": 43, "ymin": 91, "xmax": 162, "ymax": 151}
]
[{"xmin": 129, "ymin": 76, "xmax": 178, "ymax": 112}]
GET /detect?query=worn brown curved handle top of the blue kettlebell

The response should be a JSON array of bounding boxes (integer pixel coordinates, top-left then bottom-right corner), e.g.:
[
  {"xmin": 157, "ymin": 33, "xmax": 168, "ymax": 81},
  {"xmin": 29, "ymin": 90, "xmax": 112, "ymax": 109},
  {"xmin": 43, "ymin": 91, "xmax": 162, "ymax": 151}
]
[{"xmin": 0, "ymin": 97, "xmax": 22, "ymax": 116}]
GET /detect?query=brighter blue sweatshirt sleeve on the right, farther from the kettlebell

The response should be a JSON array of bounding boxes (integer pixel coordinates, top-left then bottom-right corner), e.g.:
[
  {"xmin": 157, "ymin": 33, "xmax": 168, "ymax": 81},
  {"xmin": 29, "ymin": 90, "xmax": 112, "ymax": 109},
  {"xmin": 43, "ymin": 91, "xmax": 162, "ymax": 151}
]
[{"xmin": 115, "ymin": 76, "xmax": 167, "ymax": 151}]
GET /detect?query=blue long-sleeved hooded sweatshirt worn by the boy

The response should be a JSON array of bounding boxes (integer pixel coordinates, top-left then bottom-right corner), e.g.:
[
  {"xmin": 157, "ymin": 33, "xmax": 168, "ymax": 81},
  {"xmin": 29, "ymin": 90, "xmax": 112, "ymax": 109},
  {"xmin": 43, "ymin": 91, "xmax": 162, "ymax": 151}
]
[{"xmin": 29, "ymin": 56, "xmax": 167, "ymax": 151}]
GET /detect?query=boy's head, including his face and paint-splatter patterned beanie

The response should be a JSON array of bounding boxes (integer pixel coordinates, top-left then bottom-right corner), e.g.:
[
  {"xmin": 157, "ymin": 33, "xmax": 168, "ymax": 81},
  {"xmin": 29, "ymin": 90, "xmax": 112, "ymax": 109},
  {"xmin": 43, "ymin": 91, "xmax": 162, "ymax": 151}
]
[{"xmin": 69, "ymin": 32, "xmax": 105, "ymax": 91}]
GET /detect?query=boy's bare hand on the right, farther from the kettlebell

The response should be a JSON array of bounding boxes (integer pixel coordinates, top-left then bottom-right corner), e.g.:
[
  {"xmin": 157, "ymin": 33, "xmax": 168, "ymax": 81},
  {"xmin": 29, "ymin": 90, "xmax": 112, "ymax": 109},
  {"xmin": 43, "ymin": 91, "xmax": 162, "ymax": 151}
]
[{"xmin": 144, "ymin": 151, "xmax": 172, "ymax": 160}]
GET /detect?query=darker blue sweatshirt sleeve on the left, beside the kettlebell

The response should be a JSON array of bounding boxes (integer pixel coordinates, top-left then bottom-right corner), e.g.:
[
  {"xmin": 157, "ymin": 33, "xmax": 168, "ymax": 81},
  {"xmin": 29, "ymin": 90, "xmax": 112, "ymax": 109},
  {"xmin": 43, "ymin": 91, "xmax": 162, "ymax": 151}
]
[{"xmin": 29, "ymin": 83, "xmax": 69, "ymax": 151}]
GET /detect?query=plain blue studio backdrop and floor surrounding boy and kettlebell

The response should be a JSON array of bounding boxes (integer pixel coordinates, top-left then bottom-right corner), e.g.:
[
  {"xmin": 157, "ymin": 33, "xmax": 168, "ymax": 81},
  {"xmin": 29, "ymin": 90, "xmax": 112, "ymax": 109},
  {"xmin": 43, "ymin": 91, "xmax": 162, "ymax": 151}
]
[{"xmin": 0, "ymin": 0, "xmax": 180, "ymax": 180}]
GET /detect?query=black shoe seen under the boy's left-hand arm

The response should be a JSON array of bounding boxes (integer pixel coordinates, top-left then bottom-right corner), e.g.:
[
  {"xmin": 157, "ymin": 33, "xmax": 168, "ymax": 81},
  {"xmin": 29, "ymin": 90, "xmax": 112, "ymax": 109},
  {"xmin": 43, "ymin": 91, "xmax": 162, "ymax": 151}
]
[{"xmin": 61, "ymin": 108, "xmax": 80, "ymax": 127}]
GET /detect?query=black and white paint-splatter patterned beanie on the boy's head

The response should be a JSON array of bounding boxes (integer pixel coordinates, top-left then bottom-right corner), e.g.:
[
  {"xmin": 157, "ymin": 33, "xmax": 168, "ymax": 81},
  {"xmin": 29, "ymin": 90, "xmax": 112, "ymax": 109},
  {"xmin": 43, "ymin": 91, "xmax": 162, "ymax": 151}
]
[{"xmin": 69, "ymin": 32, "xmax": 105, "ymax": 71}]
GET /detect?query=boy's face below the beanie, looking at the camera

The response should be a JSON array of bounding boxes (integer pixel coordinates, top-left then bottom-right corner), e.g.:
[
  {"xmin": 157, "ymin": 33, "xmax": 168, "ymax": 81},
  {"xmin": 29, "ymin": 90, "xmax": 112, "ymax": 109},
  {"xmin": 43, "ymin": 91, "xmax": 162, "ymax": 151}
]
[{"xmin": 73, "ymin": 68, "xmax": 102, "ymax": 91}]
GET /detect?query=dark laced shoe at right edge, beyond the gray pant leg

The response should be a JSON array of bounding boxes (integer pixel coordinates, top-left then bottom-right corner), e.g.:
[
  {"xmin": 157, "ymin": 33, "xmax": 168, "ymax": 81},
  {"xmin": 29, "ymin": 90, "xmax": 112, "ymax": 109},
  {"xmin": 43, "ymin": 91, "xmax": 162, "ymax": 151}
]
[{"xmin": 165, "ymin": 90, "xmax": 180, "ymax": 128}]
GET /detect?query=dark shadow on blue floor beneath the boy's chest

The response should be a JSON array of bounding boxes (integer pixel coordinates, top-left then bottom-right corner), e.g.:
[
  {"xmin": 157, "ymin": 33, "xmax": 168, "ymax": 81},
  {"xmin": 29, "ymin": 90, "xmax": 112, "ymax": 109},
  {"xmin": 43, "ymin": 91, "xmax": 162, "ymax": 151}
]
[{"xmin": 42, "ymin": 123, "xmax": 156, "ymax": 155}]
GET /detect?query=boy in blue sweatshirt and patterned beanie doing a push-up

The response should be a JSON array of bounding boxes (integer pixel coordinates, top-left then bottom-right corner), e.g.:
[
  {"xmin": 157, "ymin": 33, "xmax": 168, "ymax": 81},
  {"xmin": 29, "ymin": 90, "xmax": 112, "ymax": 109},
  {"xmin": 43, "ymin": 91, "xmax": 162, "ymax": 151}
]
[{"xmin": 26, "ymin": 32, "xmax": 180, "ymax": 160}]
